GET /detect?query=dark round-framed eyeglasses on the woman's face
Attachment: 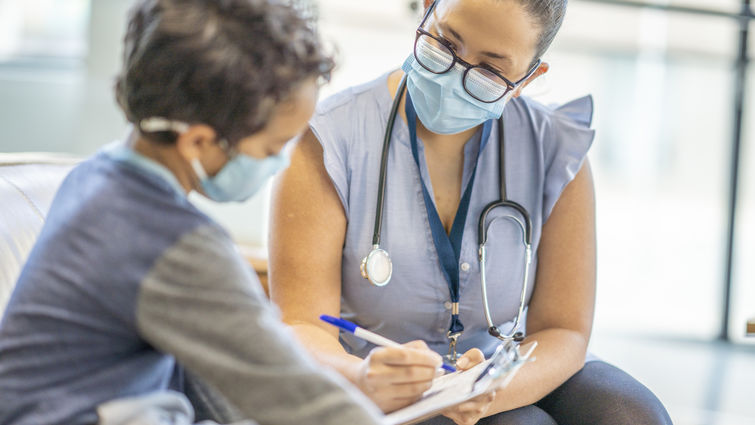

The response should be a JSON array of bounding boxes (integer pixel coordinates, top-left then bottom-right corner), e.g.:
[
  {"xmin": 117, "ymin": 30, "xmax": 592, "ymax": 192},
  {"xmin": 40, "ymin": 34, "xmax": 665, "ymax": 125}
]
[{"xmin": 414, "ymin": 0, "xmax": 541, "ymax": 103}]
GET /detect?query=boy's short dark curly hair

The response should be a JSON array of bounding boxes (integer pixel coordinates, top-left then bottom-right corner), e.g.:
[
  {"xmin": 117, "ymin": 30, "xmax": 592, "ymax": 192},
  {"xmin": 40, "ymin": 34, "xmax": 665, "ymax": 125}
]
[{"xmin": 116, "ymin": 0, "xmax": 333, "ymax": 145}]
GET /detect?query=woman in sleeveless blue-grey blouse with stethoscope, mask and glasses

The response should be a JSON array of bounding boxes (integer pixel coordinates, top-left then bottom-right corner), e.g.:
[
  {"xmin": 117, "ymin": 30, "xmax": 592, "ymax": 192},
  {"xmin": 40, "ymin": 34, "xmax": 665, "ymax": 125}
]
[{"xmin": 270, "ymin": 0, "xmax": 670, "ymax": 424}]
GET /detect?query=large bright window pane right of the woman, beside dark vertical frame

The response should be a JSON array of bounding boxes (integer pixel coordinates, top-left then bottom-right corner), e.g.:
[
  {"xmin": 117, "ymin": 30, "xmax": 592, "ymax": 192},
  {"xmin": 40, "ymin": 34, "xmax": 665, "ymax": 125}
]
[{"xmin": 530, "ymin": 2, "xmax": 738, "ymax": 339}]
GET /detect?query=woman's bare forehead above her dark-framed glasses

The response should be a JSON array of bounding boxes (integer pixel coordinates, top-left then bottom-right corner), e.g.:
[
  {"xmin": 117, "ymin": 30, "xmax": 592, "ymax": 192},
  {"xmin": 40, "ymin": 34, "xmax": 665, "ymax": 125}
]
[{"xmin": 425, "ymin": 0, "xmax": 540, "ymax": 81}]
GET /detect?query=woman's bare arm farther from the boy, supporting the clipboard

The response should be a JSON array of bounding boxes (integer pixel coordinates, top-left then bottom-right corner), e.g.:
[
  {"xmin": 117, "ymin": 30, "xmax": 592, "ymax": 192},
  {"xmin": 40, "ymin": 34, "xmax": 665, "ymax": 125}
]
[{"xmin": 485, "ymin": 160, "xmax": 596, "ymax": 416}]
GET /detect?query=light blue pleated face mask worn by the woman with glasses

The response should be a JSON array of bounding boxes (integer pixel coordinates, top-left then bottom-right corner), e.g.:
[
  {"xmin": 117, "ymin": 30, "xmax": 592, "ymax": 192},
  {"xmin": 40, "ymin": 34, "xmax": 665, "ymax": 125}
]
[{"xmin": 401, "ymin": 55, "xmax": 514, "ymax": 134}]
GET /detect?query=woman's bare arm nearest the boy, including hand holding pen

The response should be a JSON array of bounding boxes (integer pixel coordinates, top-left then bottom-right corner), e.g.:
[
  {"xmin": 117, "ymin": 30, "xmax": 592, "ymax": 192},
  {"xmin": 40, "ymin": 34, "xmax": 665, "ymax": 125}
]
[{"xmin": 269, "ymin": 131, "xmax": 441, "ymax": 412}]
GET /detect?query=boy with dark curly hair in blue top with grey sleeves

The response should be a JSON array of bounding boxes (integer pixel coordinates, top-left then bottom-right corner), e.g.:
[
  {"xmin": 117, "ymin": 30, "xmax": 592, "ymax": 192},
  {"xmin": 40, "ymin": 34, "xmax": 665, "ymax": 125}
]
[{"xmin": 0, "ymin": 0, "xmax": 380, "ymax": 425}]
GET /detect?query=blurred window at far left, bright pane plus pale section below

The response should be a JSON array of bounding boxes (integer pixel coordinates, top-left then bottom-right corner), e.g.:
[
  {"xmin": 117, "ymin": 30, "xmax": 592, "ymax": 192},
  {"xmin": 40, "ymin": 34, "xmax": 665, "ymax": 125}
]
[{"xmin": 0, "ymin": 0, "xmax": 96, "ymax": 153}]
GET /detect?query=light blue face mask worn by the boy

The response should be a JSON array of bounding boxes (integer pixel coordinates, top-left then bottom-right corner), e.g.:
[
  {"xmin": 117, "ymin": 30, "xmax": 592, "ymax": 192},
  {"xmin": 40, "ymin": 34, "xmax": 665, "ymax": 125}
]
[{"xmin": 191, "ymin": 152, "xmax": 289, "ymax": 202}]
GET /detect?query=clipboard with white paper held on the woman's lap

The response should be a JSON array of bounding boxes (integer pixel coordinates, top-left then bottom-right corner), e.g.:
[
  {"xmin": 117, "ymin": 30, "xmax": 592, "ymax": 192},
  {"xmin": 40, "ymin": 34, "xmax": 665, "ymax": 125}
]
[{"xmin": 383, "ymin": 341, "xmax": 537, "ymax": 425}]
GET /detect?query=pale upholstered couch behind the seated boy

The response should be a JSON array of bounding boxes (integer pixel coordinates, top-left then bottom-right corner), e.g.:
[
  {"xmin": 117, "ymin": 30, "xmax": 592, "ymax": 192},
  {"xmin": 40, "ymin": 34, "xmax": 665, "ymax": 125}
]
[{"xmin": 0, "ymin": 153, "xmax": 267, "ymax": 317}]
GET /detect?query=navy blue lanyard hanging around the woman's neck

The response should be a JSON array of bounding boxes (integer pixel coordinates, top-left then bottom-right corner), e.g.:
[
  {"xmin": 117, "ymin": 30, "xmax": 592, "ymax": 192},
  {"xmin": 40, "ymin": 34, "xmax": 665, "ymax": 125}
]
[{"xmin": 406, "ymin": 90, "xmax": 493, "ymax": 335}]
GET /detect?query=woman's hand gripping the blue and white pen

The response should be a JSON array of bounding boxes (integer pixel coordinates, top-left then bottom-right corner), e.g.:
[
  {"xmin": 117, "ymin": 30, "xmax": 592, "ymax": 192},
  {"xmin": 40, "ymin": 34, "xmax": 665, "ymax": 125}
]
[{"xmin": 357, "ymin": 341, "xmax": 443, "ymax": 413}]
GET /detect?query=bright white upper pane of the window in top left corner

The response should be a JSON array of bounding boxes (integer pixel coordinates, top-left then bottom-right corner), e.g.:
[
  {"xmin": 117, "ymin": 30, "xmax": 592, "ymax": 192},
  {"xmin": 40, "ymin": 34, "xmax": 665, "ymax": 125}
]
[{"xmin": 0, "ymin": 0, "xmax": 89, "ymax": 63}]
